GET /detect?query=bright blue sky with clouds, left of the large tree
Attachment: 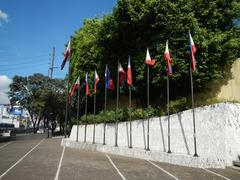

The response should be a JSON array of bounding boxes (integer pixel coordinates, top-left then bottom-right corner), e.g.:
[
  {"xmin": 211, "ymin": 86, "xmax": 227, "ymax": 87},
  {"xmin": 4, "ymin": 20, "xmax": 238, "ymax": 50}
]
[{"xmin": 0, "ymin": 0, "xmax": 116, "ymax": 104}]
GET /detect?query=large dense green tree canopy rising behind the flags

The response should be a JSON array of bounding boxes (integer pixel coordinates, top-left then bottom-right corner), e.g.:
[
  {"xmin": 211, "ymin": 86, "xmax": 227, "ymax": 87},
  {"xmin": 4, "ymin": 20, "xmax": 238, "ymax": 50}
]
[{"xmin": 67, "ymin": 0, "xmax": 240, "ymax": 108}]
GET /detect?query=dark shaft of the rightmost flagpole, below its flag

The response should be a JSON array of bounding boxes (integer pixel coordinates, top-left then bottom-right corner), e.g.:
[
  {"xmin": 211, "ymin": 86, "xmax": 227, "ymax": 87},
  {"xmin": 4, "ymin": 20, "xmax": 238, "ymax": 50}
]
[{"xmin": 190, "ymin": 61, "xmax": 198, "ymax": 157}]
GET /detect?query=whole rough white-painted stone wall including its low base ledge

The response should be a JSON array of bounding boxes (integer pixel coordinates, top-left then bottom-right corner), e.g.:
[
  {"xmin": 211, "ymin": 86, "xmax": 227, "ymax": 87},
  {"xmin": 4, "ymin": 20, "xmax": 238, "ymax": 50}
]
[{"xmin": 62, "ymin": 103, "xmax": 240, "ymax": 168}]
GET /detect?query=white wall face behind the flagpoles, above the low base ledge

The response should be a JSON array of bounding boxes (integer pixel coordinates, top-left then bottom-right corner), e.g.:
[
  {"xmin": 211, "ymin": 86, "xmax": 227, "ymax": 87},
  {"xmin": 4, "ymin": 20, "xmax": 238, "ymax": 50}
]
[{"xmin": 70, "ymin": 103, "xmax": 240, "ymax": 165}]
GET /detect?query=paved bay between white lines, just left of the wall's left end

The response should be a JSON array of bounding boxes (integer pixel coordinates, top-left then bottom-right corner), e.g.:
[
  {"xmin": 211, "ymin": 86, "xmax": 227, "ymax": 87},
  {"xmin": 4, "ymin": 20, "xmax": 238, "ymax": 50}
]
[{"xmin": 3, "ymin": 139, "xmax": 63, "ymax": 180}]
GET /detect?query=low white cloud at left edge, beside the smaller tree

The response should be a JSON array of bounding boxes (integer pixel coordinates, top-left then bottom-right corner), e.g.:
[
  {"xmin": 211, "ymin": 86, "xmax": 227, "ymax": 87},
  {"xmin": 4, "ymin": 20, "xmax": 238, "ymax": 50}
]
[{"xmin": 0, "ymin": 75, "xmax": 12, "ymax": 104}]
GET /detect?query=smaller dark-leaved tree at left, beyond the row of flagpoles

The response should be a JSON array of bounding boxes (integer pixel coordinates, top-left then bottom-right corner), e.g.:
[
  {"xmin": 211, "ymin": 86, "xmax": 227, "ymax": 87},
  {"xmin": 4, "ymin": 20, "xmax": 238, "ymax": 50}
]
[{"xmin": 8, "ymin": 74, "xmax": 65, "ymax": 132}]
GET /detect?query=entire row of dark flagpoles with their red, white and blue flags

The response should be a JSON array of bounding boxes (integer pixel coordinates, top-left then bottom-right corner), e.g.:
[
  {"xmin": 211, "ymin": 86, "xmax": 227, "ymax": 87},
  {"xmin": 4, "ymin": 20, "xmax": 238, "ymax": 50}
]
[{"xmin": 61, "ymin": 32, "xmax": 198, "ymax": 156}]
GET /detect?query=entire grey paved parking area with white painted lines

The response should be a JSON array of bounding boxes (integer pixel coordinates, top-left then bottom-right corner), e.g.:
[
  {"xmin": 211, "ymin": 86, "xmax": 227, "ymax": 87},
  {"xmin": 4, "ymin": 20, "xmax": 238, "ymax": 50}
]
[{"xmin": 0, "ymin": 136, "xmax": 240, "ymax": 180}]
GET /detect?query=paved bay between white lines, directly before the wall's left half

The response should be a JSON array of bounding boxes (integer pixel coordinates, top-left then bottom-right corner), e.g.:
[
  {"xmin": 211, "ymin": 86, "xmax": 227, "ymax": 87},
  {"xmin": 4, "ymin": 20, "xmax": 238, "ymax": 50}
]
[{"xmin": 59, "ymin": 148, "xmax": 121, "ymax": 180}]
